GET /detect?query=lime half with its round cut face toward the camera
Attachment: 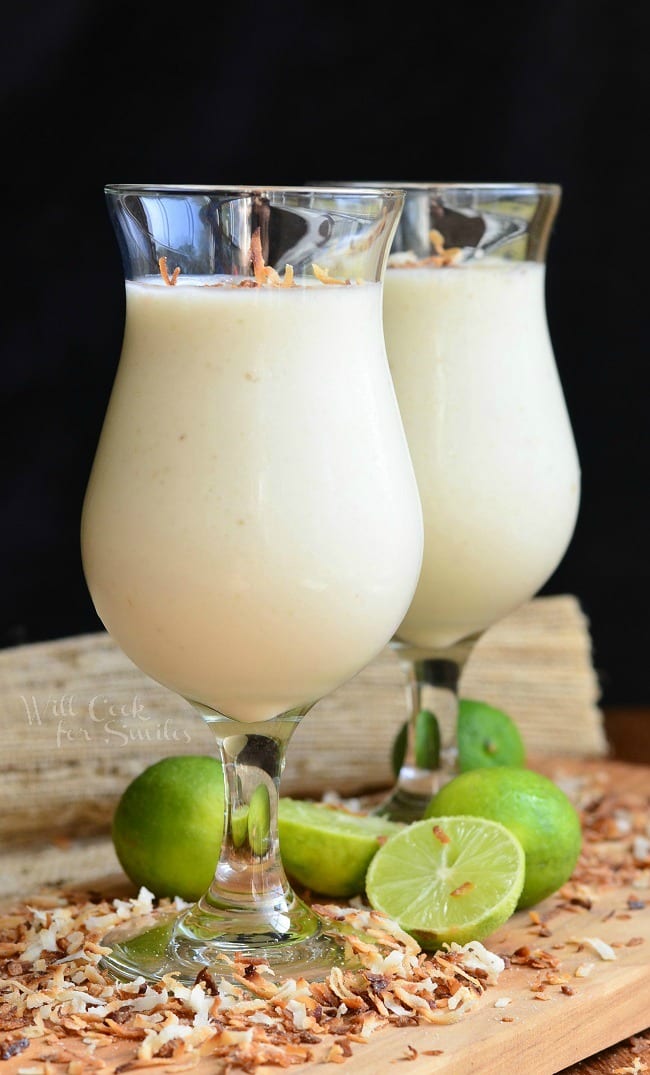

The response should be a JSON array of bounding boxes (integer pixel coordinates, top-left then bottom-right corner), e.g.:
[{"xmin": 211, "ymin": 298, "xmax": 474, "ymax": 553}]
[{"xmin": 365, "ymin": 817, "xmax": 524, "ymax": 951}]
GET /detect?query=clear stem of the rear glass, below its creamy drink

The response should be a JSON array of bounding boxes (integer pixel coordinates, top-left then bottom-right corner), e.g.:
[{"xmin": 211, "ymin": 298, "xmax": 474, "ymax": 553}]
[{"xmin": 374, "ymin": 635, "xmax": 478, "ymax": 822}]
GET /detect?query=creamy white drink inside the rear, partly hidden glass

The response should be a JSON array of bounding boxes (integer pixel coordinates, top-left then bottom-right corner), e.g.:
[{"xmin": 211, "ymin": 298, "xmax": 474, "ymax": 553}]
[{"xmin": 384, "ymin": 258, "xmax": 580, "ymax": 648}]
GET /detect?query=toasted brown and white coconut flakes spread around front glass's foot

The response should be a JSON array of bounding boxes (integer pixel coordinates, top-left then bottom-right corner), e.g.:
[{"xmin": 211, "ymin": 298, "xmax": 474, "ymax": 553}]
[{"xmin": 0, "ymin": 889, "xmax": 505, "ymax": 1075}]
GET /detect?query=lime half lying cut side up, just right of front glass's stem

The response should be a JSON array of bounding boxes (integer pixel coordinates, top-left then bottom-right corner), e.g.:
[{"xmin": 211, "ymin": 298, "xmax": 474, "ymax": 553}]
[{"xmin": 278, "ymin": 797, "xmax": 404, "ymax": 897}]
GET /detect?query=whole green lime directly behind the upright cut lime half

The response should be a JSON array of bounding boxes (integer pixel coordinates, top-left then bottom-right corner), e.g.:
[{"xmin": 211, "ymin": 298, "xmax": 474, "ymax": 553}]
[{"xmin": 424, "ymin": 765, "xmax": 582, "ymax": 907}]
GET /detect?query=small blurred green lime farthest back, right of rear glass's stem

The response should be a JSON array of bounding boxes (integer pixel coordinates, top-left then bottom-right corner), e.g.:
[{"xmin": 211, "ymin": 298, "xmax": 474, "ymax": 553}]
[{"xmin": 457, "ymin": 698, "xmax": 525, "ymax": 773}]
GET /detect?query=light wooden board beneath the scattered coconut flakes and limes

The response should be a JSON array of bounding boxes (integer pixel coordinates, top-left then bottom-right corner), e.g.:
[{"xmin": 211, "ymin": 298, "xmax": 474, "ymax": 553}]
[{"xmin": 0, "ymin": 759, "xmax": 650, "ymax": 1075}]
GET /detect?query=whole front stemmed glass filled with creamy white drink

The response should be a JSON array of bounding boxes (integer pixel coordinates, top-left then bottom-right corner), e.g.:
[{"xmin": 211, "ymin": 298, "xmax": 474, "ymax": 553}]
[{"xmin": 82, "ymin": 186, "xmax": 422, "ymax": 981}]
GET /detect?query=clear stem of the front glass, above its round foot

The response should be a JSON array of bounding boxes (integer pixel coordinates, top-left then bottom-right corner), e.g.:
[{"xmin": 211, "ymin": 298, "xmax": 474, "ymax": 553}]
[{"xmin": 176, "ymin": 710, "xmax": 318, "ymax": 951}]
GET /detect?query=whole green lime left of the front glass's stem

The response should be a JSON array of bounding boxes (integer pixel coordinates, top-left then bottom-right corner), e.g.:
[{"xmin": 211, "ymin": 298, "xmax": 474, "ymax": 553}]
[{"xmin": 112, "ymin": 755, "xmax": 223, "ymax": 901}]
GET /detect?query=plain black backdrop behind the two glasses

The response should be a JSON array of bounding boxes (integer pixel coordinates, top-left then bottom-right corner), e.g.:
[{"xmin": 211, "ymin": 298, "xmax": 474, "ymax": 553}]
[{"xmin": 0, "ymin": 0, "xmax": 650, "ymax": 704}]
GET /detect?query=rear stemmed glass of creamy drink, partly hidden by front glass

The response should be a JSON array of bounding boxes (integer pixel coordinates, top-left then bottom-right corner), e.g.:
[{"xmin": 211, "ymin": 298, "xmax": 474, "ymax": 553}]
[{"xmin": 371, "ymin": 183, "xmax": 580, "ymax": 820}]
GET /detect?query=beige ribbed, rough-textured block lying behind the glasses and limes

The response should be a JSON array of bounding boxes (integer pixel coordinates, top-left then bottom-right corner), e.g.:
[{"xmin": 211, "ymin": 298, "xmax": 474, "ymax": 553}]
[{"xmin": 0, "ymin": 596, "xmax": 608, "ymax": 847}]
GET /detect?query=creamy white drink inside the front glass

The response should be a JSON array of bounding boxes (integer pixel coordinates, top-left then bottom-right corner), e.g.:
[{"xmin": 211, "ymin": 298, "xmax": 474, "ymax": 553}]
[{"xmin": 82, "ymin": 277, "xmax": 422, "ymax": 721}]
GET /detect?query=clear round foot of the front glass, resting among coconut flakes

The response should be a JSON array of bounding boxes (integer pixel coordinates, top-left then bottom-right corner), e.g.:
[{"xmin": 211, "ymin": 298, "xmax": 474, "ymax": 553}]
[{"xmin": 100, "ymin": 900, "xmax": 352, "ymax": 986}]
